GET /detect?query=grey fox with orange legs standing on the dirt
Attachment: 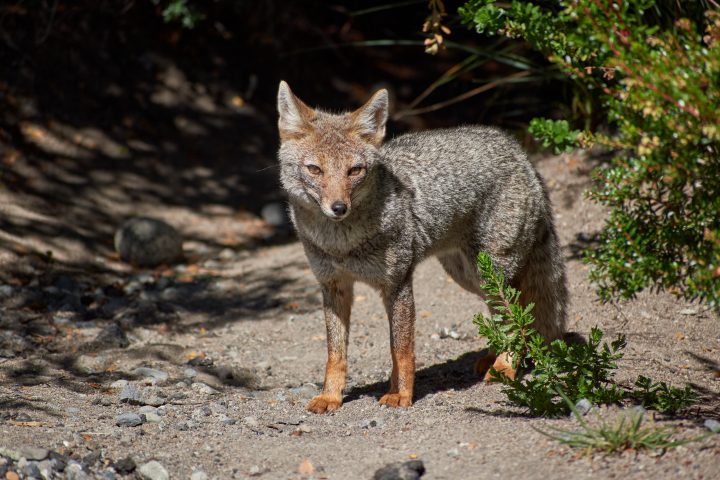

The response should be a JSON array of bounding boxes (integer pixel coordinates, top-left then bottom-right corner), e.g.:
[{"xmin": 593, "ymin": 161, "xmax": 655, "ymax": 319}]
[{"xmin": 277, "ymin": 81, "xmax": 568, "ymax": 414}]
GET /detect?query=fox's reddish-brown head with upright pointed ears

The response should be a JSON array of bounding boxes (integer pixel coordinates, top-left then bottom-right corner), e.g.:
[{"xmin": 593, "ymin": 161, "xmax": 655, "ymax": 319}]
[{"xmin": 278, "ymin": 82, "xmax": 388, "ymax": 221}]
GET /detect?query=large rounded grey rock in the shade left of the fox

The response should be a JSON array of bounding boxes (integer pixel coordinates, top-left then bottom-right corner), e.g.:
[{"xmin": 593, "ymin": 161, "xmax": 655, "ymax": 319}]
[{"xmin": 115, "ymin": 217, "xmax": 182, "ymax": 267}]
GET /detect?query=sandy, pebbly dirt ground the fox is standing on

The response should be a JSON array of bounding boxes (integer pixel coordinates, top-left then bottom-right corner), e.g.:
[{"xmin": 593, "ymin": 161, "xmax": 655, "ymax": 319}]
[{"xmin": 0, "ymin": 126, "xmax": 720, "ymax": 479}]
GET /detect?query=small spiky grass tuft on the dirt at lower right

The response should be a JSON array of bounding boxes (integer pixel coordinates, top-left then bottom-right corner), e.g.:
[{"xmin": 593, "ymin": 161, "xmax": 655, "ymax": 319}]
[{"xmin": 536, "ymin": 390, "xmax": 704, "ymax": 453}]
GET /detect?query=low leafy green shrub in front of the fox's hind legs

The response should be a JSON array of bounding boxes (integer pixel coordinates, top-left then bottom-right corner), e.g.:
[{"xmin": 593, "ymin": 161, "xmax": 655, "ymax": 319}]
[{"xmin": 474, "ymin": 252, "xmax": 694, "ymax": 416}]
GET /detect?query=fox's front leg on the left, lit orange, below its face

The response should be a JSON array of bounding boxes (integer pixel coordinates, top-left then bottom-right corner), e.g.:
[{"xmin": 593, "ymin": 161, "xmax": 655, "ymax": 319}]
[{"xmin": 307, "ymin": 279, "xmax": 353, "ymax": 413}]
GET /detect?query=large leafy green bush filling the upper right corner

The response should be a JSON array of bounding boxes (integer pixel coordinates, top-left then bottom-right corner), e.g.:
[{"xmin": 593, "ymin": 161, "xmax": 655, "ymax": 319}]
[{"xmin": 460, "ymin": 0, "xmax": 720, "ymax": 307}]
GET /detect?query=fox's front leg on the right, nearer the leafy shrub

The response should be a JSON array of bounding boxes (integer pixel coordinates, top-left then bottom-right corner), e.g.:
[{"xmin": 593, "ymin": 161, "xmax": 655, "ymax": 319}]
[{"xmin": 380, "ymin": 278, "xmax": 415, "ymax": 407}]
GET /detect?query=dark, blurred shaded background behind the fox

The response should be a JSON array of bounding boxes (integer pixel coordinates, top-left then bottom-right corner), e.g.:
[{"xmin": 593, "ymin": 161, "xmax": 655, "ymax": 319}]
[{"xmin": 0, "ymin": 0, "xmax": 582, "ymax": 255}]
